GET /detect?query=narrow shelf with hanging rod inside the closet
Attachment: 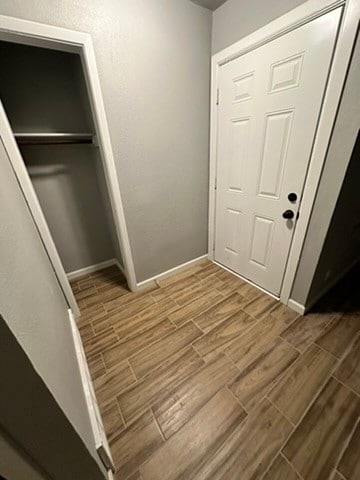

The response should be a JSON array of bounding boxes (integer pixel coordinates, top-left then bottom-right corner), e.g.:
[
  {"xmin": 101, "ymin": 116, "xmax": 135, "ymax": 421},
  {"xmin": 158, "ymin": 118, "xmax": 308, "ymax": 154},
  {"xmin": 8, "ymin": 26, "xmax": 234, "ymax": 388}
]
[{"xmin": 14, "ymin": 133, "xmax": 95, "ymax": 145}]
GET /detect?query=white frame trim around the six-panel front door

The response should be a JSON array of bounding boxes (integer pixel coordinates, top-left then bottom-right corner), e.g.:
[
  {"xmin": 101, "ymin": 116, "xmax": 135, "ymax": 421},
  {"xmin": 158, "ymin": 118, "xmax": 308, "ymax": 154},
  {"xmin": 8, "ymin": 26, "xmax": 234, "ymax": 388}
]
[{"xmin": 209, "ymin": 0, "xmax": 360, "ymax": 305}]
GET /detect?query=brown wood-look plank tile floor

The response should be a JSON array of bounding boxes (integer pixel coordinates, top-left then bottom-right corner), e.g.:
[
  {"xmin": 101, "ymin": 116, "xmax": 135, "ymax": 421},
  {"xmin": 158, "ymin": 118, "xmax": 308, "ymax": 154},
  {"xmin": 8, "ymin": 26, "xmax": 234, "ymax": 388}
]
[{"xmin": 72, "ymin": 261, "xmax": 360, "ymax": 480}]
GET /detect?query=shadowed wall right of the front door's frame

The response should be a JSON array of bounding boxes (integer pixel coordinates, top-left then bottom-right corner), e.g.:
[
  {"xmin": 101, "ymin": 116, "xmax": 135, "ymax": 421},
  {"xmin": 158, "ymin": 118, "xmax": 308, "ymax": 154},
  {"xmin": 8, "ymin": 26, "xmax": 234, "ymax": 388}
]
[{"xmin": 291, "ymin": 33, "xmax": 360, "ymax": 306}]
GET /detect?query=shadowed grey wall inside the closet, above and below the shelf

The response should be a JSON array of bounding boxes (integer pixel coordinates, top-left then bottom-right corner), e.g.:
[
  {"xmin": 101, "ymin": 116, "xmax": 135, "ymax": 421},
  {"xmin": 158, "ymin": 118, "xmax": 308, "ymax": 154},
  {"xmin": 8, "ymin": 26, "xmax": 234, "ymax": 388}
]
[{"xmin": 0, "ymin": 42, "xmax": 123, "ymax": 273}]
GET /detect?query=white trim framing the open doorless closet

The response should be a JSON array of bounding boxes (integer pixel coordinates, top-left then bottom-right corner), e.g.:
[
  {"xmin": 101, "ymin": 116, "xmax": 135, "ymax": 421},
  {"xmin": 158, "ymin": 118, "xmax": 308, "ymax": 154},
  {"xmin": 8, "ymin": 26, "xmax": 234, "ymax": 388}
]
[{"xmin": 0, "ymin": 15, "xmax": 137, "ymax": 316}]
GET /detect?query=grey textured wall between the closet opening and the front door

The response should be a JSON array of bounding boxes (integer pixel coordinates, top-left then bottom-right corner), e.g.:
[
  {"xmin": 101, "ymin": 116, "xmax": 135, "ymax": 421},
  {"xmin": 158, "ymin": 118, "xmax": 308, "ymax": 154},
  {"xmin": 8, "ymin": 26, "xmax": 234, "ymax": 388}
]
[{"xmin": 0, "ymin": 0, "xmax": 211, "ymax": 281}]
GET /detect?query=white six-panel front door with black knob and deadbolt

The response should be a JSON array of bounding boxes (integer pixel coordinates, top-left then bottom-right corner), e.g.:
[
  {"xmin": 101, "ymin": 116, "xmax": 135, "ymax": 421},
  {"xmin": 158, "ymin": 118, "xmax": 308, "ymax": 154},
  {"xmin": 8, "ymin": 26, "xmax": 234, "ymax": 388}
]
[{"xmin": 215, "ymin": 8, "xmax": 341, "ymax": 295}]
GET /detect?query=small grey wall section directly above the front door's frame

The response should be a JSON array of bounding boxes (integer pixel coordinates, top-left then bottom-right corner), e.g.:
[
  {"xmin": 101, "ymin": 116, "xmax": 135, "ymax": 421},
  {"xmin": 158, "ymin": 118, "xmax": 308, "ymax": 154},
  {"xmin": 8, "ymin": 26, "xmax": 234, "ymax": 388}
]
[{"xmin": 212, "ymin": 0, "xmax": 306, "ymax": 54}]
